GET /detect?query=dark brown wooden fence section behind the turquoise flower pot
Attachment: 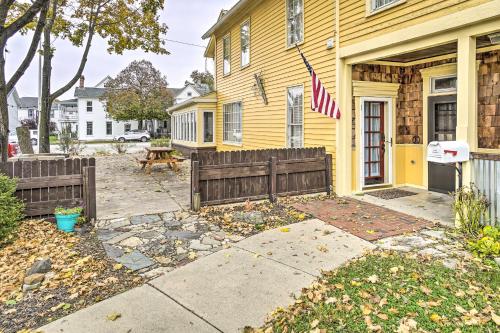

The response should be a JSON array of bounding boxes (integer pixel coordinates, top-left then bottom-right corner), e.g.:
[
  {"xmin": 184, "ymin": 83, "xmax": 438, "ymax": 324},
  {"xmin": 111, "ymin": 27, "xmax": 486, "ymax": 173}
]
[{"xmin": 0, "ymin": 158, "xmax": 96, "ymax": 220}]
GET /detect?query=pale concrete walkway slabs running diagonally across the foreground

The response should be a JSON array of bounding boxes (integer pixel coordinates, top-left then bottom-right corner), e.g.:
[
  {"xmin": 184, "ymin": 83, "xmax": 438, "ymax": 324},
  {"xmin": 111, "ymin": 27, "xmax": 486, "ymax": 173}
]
[{"xmin": 40, "ymin": 220, "xmax": 374, "ymax": 333}]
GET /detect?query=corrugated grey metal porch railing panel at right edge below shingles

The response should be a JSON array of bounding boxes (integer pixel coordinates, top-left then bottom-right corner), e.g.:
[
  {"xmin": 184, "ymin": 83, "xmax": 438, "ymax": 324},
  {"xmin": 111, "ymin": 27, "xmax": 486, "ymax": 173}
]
[{"xmin": 472, "ymin": 153, "xmax": 500, "ymax": 226}]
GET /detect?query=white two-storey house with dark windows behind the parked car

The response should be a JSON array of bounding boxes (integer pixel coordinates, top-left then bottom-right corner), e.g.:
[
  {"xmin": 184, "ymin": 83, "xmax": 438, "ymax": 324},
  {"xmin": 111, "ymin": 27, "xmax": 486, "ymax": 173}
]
[{"xmin": 75, "ymin": 76, "xmax": 139, "ymax": 141}]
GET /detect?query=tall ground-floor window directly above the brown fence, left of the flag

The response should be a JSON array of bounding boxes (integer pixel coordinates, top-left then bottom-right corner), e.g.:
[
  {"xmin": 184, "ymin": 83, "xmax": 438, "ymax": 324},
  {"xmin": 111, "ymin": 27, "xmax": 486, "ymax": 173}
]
[{"xmin": 287, "ymin": 86, "xmax": 304, "ymax": 148}]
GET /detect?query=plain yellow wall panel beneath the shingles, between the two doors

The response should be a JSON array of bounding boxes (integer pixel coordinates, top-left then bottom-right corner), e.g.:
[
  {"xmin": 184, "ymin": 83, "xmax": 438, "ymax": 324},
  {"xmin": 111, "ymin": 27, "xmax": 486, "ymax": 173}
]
[{"xmin": 396, "ymin": 145, "xmax": 424, "ymax": 187}]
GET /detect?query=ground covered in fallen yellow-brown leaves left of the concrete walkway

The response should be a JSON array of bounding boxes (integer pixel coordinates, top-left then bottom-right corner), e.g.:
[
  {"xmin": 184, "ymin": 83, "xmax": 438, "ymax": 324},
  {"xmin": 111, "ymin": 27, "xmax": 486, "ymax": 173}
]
[{"xmin": 0, "ymin": 220, "xmax": 142, "ymax": 333}]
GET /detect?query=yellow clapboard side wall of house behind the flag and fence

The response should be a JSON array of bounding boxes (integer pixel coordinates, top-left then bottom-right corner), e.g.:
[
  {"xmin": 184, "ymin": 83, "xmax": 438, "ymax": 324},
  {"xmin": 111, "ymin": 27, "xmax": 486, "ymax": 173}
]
[{"xmin": 216, "ymin": 0, "xmax": 336, "ymax": 180}]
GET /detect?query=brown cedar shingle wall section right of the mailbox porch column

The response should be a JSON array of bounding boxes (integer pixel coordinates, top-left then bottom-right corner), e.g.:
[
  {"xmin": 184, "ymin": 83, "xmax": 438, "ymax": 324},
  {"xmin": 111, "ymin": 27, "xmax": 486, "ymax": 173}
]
[{"xmin": 478, "ymin": 50, "xmax": 500, "ymax": 149}]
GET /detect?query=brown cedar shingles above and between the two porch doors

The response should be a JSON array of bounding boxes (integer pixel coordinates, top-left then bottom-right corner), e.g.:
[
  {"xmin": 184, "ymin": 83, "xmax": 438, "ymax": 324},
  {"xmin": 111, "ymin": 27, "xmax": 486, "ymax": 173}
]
[{"xmin": 352, "ymin": 59, "xmax": 458, "ymax": 144}]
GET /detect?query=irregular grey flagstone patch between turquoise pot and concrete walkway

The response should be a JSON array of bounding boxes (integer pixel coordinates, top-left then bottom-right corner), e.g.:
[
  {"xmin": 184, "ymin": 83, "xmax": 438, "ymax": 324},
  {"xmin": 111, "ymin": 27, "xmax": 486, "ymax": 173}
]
[{"xmin": 96, "ymin": 211, "xmax": 242, "ymax": 278}]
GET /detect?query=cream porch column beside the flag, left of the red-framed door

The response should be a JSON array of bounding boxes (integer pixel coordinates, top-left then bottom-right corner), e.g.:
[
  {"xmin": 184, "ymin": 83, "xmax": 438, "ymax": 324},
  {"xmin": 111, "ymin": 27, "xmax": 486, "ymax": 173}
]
[{"xmin": 335, "ymin": 59, "xmax": 352, "ymax": 195}]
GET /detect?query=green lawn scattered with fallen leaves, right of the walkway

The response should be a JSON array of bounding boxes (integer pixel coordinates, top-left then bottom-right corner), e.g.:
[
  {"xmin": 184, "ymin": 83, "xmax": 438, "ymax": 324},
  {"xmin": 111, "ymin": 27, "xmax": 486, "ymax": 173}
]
[{"xmin": 258, "ymin": 253, "xmax": 500, "ymax": 333}]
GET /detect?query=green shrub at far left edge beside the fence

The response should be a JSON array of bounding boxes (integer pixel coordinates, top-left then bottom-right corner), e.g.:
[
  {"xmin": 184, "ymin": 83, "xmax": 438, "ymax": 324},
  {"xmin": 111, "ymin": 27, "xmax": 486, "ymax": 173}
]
[{"xmin": 0, "ymin": 174, "xmax": 24, "ymax": 247}]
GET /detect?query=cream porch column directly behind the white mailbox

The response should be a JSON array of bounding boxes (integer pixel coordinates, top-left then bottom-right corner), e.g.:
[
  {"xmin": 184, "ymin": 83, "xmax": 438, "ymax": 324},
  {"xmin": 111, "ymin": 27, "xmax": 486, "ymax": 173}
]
[{"xmin": 457, "ymin": 34, "xmax": 477, "ymax": 185}]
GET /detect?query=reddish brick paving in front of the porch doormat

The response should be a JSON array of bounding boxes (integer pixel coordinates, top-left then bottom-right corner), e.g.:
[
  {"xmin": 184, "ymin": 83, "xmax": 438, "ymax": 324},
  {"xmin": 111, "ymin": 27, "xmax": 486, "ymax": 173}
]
[{"xmin": 293, "ymin": 198, "xmax": 433, "ymax": 241}]
